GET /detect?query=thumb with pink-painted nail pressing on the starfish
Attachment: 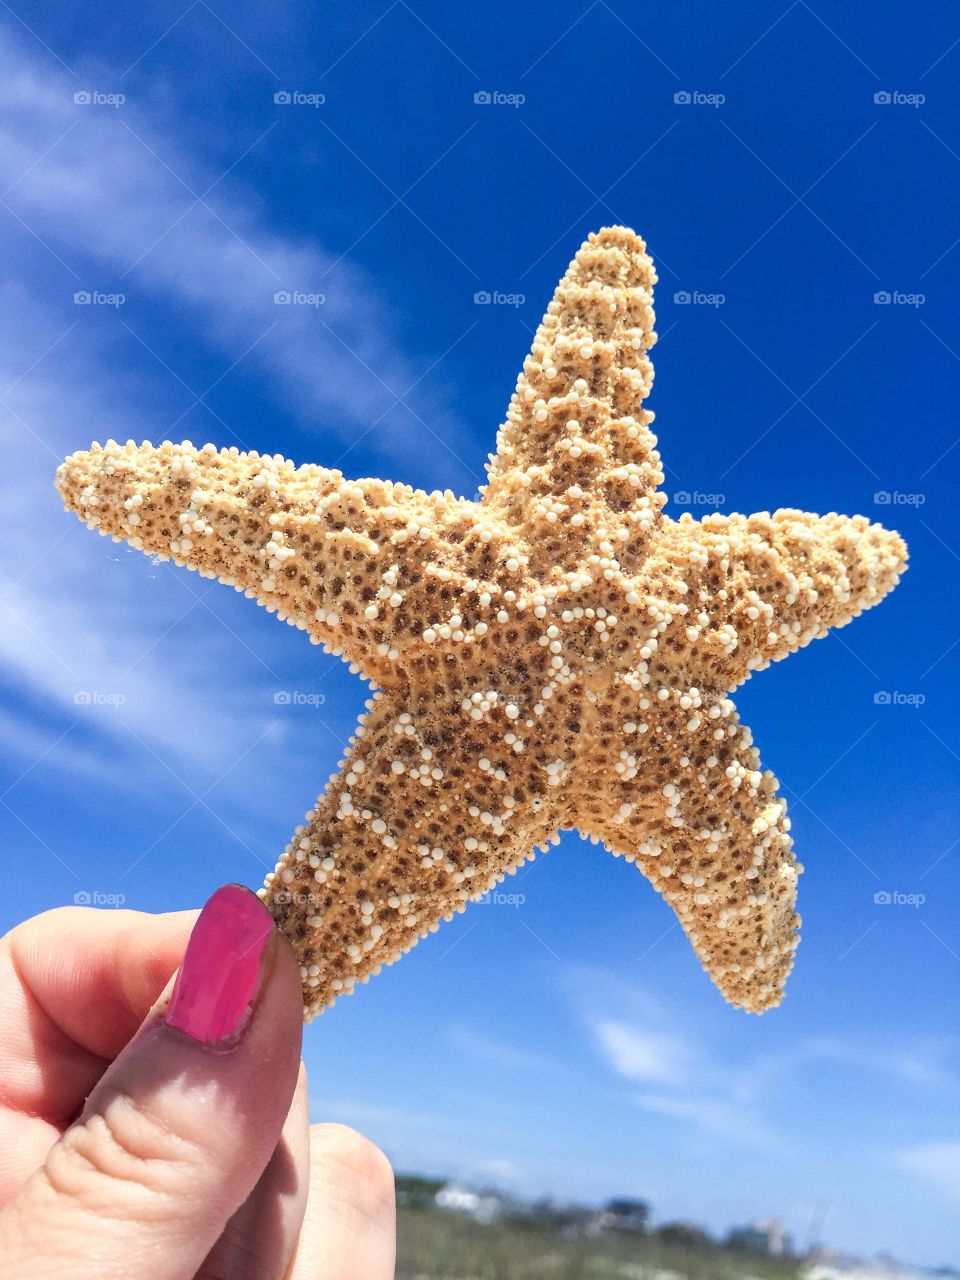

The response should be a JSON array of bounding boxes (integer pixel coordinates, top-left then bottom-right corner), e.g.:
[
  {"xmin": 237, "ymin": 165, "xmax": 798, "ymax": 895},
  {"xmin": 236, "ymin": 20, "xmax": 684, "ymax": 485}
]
[{"xmin": 0, "ymin": 884, "xmax": 302, "ymax": 1280}]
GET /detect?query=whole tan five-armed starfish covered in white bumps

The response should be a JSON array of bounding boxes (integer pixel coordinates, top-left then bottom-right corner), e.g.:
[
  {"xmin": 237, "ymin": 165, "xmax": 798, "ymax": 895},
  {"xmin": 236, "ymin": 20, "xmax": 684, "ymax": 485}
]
[{"xmin": 56, "ymin": 227, "xmax": 906, "ymax": 1018}]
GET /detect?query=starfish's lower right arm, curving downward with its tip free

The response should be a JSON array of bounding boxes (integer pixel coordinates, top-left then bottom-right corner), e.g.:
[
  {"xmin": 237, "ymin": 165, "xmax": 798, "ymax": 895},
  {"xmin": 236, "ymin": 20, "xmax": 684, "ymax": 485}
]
[{"xmin": 579, "ymin": 695, "xmax": 803, "ymax": 1012}]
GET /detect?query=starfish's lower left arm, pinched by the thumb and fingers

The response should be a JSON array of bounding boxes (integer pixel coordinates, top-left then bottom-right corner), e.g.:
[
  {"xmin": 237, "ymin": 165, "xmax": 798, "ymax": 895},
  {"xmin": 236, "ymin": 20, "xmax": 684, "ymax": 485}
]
[{"xmin": 261, "ymin": 687, "xmax": 557, "ymax": 1016}]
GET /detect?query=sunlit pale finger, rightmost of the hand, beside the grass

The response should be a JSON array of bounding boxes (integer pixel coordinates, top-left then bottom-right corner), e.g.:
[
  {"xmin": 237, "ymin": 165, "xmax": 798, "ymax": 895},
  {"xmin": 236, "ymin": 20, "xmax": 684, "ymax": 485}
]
[{"xmin": 287, "ymin": 1124, "xmax": 397, "ymax": 1280}]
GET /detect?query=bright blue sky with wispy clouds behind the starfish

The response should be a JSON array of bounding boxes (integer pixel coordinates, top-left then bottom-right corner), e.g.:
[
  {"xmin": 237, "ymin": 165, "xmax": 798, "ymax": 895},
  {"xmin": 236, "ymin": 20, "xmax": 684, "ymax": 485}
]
[{"xmin": 0, "ymin": 0, "xmax": 960, "ymax": 1263}]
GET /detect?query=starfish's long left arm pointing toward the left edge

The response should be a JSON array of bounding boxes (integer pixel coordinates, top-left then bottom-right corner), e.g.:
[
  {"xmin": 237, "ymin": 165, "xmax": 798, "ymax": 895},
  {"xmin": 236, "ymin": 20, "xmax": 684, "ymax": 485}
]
[{"xmin": 56, "ymin": 442, "xmax": 488, "ymax": 684}]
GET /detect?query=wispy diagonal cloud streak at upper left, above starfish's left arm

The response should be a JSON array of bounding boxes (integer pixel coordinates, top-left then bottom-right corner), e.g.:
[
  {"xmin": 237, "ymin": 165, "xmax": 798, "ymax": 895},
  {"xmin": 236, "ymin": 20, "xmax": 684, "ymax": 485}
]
[{"xmin": 0, "ymin": 35, "xmax": 468, "ymax": 485}]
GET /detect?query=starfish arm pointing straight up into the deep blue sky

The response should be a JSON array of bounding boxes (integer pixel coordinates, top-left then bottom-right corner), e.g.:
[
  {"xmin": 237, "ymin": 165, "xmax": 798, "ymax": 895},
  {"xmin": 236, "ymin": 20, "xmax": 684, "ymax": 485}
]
[{"xmin": 484, "ymin": 227, "xmax": 666, "ymax": 564}]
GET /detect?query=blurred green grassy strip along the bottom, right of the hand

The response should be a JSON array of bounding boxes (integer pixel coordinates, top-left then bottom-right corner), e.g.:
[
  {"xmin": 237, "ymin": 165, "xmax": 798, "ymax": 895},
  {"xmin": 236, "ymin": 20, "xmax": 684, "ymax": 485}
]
[{"xmin": 397, "ymin": 1208, "xmax": 799, "ymax": 1280}]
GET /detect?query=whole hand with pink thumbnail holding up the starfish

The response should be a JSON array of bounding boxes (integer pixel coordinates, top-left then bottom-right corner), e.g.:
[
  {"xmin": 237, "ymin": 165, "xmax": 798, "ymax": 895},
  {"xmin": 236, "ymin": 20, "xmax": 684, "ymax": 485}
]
[{"xmin": 0, "ymin": 886, "xmax": 394, "ymax": 1280}]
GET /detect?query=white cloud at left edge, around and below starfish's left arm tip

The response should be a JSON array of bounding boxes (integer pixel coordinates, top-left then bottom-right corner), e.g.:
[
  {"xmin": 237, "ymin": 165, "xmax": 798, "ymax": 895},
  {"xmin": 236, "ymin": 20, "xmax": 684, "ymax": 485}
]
[{"xmin": 0, "ymin": 288, "xmax": 289, "ymax": 768}]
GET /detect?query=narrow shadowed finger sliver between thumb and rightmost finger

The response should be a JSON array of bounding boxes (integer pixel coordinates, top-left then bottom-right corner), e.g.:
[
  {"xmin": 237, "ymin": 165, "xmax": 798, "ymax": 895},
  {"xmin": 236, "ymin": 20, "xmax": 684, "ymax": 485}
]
[{"xmin": 196, "ymin": 1062, "xmax": 310, "ymax": 1280}]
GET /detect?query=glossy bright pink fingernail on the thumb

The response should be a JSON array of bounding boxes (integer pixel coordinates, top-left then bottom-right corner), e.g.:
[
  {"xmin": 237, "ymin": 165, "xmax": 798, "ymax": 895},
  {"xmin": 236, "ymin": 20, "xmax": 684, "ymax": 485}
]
[{"xmin": 164, "ymin": 884, "xmax": 274, "ymax": 1047}]
